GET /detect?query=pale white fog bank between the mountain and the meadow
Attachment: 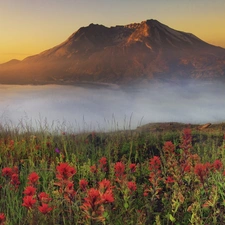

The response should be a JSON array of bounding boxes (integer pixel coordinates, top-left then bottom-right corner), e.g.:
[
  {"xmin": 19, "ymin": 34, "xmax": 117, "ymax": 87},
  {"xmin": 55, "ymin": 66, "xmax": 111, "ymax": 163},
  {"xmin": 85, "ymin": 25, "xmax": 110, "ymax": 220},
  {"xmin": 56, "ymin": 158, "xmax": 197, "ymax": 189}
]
[{"xmin": 0, "ymin": 81, "xmax": 225, "ymax": 131}]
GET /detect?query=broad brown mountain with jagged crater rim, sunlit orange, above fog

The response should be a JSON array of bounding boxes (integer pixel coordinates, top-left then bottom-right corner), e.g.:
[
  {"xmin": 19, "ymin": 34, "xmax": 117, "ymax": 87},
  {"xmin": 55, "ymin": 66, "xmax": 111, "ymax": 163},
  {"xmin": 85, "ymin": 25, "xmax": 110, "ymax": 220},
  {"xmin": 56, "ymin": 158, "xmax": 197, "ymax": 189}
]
[{"xmin": 0, "ymin": 20, "xmax": 225, "ymax": 84}]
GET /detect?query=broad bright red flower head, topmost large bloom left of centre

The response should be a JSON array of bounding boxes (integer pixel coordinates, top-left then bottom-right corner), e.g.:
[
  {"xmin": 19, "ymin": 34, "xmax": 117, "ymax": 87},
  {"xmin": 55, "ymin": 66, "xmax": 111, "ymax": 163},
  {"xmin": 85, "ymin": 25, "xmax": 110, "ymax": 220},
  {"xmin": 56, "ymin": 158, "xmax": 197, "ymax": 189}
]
[{"xmin": 56, "ymin": 163, "xmax": 76, "ymax": 180}]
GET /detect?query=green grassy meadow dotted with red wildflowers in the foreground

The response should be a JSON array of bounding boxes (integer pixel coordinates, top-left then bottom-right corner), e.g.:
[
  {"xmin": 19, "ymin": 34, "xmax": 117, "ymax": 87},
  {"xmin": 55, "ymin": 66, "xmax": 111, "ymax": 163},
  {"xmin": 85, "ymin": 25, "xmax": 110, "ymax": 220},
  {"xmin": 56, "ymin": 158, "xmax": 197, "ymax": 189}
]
[{"xmin": 0, "ymin": 125, "xmax": 225, "ymax": 225}]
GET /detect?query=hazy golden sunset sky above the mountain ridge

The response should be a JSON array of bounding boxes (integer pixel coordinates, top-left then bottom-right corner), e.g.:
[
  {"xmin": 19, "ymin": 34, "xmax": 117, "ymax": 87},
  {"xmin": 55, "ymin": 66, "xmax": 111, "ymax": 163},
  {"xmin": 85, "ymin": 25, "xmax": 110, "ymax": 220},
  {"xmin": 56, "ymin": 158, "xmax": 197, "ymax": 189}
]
[{"xmin": 0, "ymin": 0, "xmax": 225, "ymax": 63}]
